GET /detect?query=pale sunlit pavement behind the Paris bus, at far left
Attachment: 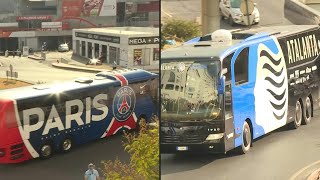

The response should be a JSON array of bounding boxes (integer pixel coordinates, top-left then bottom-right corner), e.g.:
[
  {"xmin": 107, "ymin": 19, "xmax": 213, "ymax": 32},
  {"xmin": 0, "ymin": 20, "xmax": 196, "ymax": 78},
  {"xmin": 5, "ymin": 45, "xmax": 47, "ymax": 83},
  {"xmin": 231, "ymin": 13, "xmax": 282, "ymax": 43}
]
[{"xmin": 0, "ymin": 56, "xmax": 94, "ymax": 83}]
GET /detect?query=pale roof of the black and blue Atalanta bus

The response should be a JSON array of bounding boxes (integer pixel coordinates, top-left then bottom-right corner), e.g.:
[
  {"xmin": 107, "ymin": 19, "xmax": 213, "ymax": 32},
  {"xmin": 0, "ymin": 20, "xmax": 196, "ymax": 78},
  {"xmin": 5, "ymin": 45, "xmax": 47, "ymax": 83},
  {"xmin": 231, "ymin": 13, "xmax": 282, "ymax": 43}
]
[{"xmin": 161, "ymin": 25, "xmax": 319, "ymax": 59}]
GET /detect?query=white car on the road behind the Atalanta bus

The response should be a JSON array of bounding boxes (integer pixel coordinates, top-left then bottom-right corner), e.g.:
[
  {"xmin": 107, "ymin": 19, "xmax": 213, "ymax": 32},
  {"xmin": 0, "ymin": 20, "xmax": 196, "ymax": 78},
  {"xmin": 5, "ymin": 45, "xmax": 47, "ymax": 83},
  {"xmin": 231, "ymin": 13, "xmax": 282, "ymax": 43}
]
[{"xmin": 219, "ymin": 0, "xmax": 260, "ymax": 25}]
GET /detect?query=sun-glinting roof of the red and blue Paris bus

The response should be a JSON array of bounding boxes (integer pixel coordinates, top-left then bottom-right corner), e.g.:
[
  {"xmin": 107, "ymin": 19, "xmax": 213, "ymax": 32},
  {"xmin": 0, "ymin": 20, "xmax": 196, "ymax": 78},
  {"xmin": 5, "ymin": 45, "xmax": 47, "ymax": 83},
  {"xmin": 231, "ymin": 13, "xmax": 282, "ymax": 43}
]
[{"xmin": 0, "ymin": 69, "xmax": 158, "ymax": 100}]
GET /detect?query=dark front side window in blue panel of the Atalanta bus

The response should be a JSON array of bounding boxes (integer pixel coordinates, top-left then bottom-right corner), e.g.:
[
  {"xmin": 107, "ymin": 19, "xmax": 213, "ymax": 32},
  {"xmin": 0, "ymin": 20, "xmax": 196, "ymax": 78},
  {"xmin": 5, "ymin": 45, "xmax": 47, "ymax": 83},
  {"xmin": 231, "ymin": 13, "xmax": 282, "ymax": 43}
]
[{"xmin": 234, "ymin": 48, "xmax": 249, "ymax": 85}]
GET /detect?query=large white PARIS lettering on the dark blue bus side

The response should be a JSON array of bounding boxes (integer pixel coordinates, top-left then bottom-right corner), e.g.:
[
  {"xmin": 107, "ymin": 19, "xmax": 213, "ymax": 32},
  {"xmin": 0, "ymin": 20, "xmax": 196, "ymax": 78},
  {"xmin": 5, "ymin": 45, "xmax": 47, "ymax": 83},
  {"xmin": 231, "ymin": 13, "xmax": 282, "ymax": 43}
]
[{"xmin": 22, "ymin": 94, "xmax": 109, "ymax": 139}]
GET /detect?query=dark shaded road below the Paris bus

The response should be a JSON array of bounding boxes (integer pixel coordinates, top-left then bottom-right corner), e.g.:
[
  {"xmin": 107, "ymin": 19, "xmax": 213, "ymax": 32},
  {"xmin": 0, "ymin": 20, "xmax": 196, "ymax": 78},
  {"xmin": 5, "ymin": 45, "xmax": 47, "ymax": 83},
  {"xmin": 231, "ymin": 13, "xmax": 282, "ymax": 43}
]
[{"xmin": 0, "ymin": 134, "xmax": 129, "ymax": 180}]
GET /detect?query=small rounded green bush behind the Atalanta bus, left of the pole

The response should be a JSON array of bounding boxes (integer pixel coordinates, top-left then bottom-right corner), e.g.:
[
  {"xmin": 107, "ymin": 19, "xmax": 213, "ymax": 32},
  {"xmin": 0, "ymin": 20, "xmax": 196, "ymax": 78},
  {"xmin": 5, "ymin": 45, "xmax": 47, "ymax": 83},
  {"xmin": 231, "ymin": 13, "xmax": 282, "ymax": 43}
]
[{"xmin": 161, "ymin": 19, "xmax": 201, "ymax": 41}]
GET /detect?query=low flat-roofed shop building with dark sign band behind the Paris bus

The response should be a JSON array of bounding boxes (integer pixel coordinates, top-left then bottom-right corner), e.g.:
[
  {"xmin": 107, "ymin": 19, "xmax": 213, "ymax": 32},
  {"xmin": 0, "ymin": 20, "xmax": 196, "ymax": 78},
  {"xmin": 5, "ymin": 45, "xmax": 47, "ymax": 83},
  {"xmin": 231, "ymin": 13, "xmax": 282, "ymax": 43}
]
[{"xmin": 72, "ymin": 27, "xmax": 160, "ymax": 69}]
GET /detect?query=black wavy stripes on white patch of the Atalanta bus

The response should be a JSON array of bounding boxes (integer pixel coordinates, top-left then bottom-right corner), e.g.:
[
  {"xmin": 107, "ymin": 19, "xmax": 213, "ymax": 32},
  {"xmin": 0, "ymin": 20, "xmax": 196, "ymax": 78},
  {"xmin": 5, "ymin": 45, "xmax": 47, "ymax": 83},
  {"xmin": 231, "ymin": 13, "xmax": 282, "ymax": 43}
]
[{"xmin": 260, "ymin": 50, "xmax": 287, "ymax": 120}]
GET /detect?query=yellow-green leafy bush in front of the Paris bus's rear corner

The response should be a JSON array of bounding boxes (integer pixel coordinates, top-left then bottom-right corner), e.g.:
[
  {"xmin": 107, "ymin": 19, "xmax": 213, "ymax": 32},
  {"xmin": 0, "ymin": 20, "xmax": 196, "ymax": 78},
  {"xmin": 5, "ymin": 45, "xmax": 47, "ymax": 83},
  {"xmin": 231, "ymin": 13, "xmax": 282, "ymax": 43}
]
[{"xmin": 102, "ymin": 119, "xmax": 159, "ymax": 180}]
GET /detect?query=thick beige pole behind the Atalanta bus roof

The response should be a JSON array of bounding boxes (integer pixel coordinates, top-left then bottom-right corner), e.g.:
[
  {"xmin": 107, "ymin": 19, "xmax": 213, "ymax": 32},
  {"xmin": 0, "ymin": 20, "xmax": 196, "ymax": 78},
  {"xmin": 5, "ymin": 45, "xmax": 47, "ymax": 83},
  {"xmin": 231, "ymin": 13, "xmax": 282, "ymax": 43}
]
[{"xmin": 201, "ymin": 0, "xmax": 220, "ymax": 35}]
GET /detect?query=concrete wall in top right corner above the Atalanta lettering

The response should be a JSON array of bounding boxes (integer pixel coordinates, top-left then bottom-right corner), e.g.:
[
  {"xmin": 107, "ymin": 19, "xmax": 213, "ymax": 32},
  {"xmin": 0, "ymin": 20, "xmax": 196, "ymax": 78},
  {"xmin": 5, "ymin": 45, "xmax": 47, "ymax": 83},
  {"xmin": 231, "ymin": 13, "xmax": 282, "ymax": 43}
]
[{"xmin": 284, "ymin": 0, "xmax": 320, "ymax": 25}]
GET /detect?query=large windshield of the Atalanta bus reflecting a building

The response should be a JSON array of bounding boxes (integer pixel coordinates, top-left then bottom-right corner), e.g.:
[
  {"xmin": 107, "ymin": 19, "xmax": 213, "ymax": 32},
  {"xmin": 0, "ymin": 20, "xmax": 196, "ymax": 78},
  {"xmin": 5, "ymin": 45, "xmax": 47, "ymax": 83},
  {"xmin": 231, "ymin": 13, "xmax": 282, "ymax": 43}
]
[{"xmin": 161, "ymin": 60, "xmax": 221, "ymax": 121}]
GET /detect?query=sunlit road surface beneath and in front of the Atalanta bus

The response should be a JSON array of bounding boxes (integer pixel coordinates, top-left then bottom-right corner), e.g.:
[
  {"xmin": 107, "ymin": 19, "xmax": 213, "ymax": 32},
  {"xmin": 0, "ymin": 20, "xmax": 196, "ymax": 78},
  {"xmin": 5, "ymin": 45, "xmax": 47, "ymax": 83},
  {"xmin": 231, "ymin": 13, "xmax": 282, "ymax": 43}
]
[{"xmin": 161, "ymin": 111, "xmax": 320, "ymax": 180}]
